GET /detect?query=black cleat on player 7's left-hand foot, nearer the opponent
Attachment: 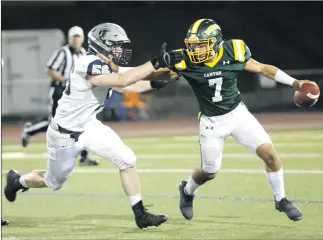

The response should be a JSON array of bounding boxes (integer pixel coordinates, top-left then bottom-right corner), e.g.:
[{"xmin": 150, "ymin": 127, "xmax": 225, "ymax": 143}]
[{"xmin": 178, "ymin": 181, "xmax": 194, "ymax": 220}]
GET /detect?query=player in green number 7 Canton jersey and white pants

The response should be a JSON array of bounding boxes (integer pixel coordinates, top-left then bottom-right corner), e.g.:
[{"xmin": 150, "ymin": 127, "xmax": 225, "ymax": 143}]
[{"xmin": 165, "ymin": 19, "xmax": 316, "ymax": 221}]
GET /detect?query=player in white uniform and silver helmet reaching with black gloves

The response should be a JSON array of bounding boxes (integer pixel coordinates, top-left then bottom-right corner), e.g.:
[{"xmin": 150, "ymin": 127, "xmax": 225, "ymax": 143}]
[{"xmin": 4, "ymin": 23, "xmax": 183, "ymax": 228}]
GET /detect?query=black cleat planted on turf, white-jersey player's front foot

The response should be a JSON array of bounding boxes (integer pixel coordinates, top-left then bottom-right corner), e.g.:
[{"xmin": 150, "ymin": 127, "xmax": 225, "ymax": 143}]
[{"xmin": 132, "ymin": 201, "xmax": 168, "ymax": 229}]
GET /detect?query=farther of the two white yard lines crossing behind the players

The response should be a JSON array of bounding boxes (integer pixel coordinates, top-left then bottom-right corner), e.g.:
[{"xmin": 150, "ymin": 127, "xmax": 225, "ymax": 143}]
[{"xmin": 2, "ymin": 152, "xmax": 323, "ymax": 161}]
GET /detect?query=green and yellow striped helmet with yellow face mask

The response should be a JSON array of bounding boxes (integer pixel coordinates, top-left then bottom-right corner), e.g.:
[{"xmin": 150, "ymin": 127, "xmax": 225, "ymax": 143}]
[{"xmin": 184, "ymin": 19, "xmax": 222, "ymax": 63}]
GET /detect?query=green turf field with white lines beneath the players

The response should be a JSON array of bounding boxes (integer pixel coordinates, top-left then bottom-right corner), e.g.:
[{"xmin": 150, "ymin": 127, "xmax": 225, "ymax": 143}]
[{"xmin": 2, "ymin": 130, "xmax": 323, "ymax": 239}]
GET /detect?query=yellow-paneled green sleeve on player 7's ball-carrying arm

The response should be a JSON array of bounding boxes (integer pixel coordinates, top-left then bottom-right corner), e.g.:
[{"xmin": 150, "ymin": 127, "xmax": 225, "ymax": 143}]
[{"xmin": 226, "ymin": 39, "xmax": 251, "ymax": 71}]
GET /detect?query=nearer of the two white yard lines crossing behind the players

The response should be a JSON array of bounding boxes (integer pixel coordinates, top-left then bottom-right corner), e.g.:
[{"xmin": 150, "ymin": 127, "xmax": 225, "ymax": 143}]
[{"xmin": 2, "ymin": 168, "xmax": 323, "ymax": 175}]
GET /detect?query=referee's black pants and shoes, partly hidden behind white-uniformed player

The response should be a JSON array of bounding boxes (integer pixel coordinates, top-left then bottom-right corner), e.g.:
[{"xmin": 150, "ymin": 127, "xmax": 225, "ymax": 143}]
[{"xmin": 21, "ymin": 81, "xmax": 99, "ymax": 166}]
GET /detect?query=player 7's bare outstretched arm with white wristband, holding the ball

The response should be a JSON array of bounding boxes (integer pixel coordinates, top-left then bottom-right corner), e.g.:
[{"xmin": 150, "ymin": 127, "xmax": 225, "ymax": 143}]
[{"xmin": 244, "ymin": 58, "xmax": 311, "ymax": 89}]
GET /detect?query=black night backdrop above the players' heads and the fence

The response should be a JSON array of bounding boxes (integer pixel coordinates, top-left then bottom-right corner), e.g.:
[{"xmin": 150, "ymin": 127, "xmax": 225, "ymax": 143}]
[{"xmin": 1, "ymin": 1, "xmax": 323, "ymax": 69}]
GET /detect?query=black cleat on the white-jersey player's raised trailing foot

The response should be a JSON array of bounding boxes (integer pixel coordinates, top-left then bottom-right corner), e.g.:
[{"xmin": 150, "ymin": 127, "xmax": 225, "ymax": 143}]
[{"xmin": 4, "ymin": 170, "xmax": 28, "ymax": 202}]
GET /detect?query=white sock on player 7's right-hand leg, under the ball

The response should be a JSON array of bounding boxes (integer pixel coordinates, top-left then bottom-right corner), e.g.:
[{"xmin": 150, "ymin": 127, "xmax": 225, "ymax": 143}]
[{"xmin": 266, "ymin": 168, "xmax": 285, "ymax": 201}]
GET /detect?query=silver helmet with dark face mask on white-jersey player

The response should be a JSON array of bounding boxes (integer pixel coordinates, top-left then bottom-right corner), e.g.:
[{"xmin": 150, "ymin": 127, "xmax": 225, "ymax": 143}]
[{"xmin": 88, "ymin": 23, "xmax": 132, "ymax": 65}]
